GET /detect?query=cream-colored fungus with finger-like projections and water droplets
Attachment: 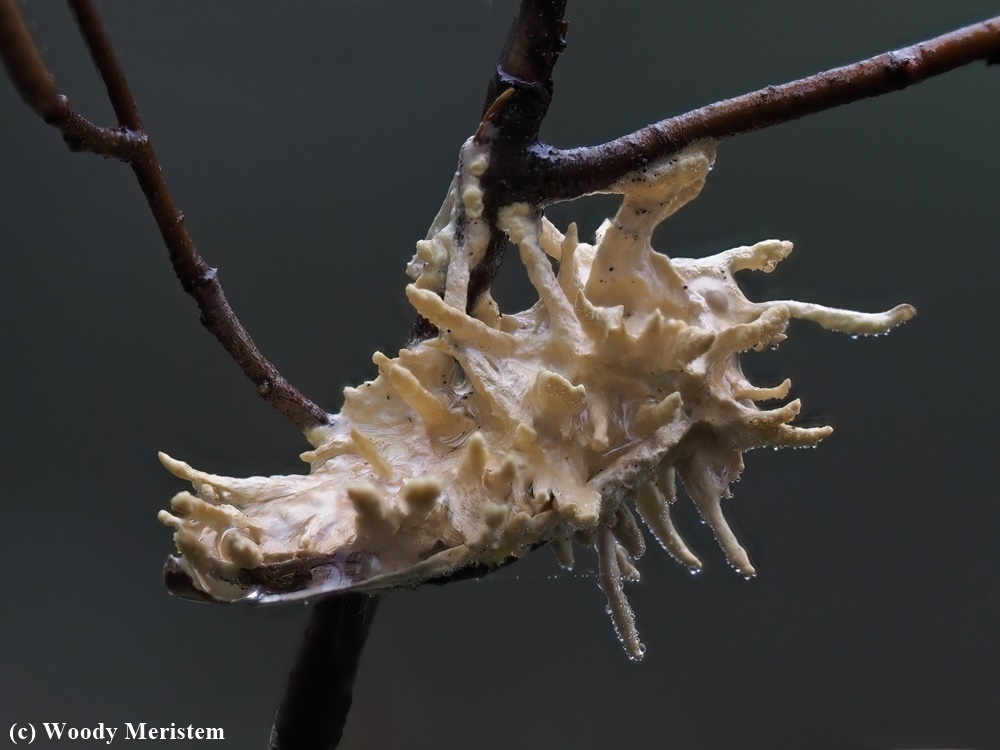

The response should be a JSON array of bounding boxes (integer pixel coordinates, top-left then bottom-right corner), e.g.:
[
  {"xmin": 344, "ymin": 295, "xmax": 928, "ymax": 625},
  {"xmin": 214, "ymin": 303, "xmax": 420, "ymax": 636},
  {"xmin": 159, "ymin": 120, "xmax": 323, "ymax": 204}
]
[{"xmin": 160, "ymin": 141, "xmax": 914, "ymax": 659}]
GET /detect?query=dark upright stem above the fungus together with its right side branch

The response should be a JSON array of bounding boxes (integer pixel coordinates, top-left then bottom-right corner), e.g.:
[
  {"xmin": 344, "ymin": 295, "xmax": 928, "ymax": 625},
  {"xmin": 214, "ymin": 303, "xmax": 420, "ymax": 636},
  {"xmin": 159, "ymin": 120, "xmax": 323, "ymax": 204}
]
[{"xmin": 469, "ymin": 0, "xmax": 1000, "ymax": 308}]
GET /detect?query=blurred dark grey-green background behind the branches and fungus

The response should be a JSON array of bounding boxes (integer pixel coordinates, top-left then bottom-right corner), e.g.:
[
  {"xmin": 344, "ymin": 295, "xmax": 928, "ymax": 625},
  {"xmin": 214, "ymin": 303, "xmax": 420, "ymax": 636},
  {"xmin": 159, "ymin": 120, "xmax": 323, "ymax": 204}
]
[{"xmin": 0, "ymin": 0, "xmax": 1000, "ymax": 750}]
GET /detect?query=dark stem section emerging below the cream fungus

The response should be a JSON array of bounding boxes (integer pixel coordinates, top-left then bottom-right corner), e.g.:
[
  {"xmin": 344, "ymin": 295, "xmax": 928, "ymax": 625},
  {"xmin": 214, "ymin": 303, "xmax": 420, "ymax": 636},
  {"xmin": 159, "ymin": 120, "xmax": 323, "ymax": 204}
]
[{"xmin": 270, "ymin": 594, "xmax": 378, "ymax": 750}]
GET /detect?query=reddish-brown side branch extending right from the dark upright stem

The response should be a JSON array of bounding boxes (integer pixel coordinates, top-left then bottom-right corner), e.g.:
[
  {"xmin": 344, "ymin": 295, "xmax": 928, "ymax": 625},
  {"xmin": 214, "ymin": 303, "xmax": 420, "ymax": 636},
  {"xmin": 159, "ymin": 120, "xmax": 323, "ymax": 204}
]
[{"xmin": 540, "ymin": 16, "xmax": 1000, "ymax": 205}]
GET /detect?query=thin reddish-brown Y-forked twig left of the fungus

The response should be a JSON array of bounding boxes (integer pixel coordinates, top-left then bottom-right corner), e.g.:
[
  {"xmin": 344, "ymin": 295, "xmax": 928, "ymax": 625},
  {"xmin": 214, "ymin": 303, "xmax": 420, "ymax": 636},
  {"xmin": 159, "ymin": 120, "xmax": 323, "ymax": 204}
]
[{"xmin": 0, "ymin": 0, "xmax": 329, "ymax": 430}]
